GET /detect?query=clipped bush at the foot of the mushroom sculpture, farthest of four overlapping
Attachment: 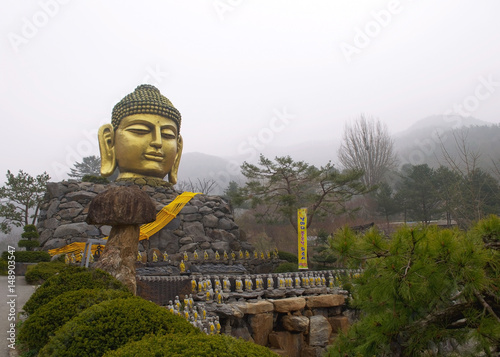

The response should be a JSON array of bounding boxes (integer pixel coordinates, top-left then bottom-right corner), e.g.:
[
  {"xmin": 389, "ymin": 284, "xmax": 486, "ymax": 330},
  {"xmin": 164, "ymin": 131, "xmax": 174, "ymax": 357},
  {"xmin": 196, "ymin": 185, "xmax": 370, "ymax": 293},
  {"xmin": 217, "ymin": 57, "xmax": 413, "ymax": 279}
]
[{"xmin": 24, "ymin": 266, "xmax": 128, "ymax": 314}]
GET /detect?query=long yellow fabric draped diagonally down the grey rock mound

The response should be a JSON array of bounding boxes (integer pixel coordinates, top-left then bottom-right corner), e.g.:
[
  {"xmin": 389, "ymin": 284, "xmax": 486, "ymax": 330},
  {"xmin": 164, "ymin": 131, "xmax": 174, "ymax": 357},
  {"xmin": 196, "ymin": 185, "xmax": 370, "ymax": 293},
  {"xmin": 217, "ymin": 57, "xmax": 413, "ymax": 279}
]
[{"xmin": 49, "ymin": 192, "xmax": 198, "ymax": 256}]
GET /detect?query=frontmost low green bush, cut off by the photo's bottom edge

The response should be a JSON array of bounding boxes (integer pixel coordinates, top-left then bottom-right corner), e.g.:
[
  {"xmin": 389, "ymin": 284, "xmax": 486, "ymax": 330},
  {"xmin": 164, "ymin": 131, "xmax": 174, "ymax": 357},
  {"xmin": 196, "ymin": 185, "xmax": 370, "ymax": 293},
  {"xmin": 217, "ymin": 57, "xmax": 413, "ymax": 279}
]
[{"xmin": 104, "ymin": 334, "xmax": 276, "ymax": 357}]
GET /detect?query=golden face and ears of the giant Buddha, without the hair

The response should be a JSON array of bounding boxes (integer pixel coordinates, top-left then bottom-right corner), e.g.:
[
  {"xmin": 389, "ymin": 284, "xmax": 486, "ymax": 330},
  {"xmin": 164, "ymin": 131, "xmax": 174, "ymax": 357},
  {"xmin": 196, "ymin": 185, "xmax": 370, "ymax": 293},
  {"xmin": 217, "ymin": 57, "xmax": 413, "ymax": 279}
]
[{"xmin": 99, "ymin": 114, "xmax": 182, "ymax": 184}]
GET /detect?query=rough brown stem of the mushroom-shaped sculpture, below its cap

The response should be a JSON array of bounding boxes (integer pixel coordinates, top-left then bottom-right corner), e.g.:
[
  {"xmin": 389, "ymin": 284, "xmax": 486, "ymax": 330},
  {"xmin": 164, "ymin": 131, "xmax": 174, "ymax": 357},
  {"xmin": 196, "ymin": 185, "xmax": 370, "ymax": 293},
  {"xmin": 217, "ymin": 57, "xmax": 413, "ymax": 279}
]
[{"xmin": 95, "ymin": 225, "xmax": 140, "ymax": 295}]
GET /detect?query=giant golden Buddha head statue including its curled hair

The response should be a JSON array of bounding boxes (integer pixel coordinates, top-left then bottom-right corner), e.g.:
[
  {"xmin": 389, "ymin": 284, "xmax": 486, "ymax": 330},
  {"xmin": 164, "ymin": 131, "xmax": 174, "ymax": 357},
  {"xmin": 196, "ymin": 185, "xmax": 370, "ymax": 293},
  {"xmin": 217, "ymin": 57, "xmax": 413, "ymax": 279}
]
[{"xmin": 98, "ymin": 84, "xmax": 182, "ymax": 185}]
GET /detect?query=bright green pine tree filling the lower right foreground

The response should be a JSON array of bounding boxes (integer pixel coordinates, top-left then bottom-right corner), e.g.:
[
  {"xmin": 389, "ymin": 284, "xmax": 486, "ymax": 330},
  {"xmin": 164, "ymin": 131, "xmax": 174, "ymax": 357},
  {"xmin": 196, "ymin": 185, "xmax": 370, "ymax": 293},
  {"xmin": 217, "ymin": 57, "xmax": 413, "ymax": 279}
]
[{"xmin": 329, "ymin": 216, "xmax": 500, "ymax": 356}]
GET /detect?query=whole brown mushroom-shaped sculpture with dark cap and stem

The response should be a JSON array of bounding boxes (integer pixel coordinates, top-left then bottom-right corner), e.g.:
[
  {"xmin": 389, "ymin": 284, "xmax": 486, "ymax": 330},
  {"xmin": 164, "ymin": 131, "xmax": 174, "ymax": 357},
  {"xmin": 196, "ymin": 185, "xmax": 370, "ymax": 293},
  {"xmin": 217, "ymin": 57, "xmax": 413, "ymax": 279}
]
[{"xmin": 86, "ymin": 186, "xmax": 156, "ymax": 295}]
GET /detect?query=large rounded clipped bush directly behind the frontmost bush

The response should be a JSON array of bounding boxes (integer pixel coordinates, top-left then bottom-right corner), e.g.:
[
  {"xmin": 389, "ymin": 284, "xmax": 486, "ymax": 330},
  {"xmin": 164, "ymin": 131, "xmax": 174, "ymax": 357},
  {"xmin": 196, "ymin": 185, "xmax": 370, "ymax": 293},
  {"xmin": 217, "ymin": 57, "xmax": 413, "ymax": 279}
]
[{"xmin": 39, "ymin": 297, "xmax": 202, "ymax": 357}]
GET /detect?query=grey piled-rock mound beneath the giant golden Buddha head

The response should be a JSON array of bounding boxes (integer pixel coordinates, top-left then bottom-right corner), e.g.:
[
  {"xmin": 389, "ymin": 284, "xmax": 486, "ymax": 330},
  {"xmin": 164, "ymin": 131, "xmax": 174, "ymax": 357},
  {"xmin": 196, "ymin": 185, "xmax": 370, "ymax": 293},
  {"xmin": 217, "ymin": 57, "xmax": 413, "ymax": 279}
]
[{"xmin": 38, "ymin": 180, "xmax": 254, "ymax": 268}]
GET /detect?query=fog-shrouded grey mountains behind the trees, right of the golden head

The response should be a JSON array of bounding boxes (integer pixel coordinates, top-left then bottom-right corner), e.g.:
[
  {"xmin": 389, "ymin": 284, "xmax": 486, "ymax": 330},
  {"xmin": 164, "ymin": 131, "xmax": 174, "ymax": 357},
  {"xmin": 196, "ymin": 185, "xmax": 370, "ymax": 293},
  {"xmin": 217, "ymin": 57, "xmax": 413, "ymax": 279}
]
[{"xmin": 179, "ymin": 115, "xmax": 500, "ymax": 194}]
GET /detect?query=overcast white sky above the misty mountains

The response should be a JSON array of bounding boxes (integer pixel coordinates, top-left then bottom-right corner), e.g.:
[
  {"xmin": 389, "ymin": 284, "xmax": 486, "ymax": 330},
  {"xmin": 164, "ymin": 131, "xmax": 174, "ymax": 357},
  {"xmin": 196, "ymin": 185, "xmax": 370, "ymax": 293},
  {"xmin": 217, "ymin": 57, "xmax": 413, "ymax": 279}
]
[{"xmin": 0, "ymin": 0, "xmax": 500, "ymax": 181}]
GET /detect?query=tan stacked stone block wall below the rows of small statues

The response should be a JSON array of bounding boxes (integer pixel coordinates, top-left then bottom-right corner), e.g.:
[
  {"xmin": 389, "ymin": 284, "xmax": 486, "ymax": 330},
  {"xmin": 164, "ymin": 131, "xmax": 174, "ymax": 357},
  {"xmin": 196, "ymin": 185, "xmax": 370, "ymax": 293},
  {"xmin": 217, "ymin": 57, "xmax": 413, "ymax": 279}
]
[{"xmin": 207, "ymin": 294, "xmax": 349, "ymax": 357}]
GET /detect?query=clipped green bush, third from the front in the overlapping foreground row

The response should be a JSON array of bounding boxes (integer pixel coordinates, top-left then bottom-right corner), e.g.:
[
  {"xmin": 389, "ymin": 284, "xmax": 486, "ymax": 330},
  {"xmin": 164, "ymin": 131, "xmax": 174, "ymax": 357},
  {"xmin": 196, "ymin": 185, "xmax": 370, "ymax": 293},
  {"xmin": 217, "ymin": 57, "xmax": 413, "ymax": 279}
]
[{"xmin": 19, "ymin": 289, "xmax": 132, "ymax": 351}]
